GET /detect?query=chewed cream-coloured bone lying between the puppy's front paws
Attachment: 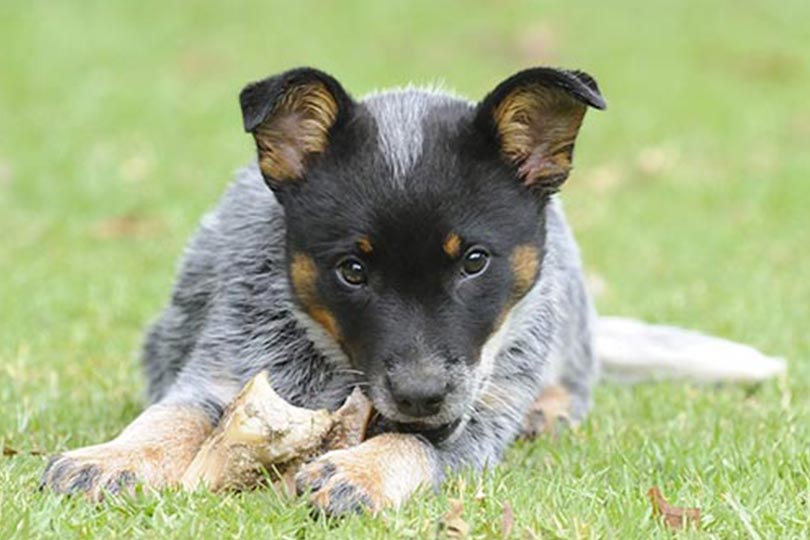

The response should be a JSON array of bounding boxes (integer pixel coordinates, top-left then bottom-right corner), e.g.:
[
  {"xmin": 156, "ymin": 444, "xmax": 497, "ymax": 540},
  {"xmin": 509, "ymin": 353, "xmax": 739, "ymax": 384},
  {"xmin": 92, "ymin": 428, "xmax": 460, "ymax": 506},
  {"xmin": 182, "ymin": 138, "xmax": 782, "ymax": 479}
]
[{"xmin": 182, "ymin": 371, "xmax": 372, "ymax": 492}]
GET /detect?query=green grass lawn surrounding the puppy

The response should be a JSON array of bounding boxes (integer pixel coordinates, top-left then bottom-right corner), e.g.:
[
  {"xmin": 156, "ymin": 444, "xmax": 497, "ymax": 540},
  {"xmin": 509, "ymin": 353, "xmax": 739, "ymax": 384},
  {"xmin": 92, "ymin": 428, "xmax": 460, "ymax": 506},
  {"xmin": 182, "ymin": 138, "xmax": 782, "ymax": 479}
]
[{"xmin": 0, "ymin": 0, "xmax": 810, "ymax": 539}]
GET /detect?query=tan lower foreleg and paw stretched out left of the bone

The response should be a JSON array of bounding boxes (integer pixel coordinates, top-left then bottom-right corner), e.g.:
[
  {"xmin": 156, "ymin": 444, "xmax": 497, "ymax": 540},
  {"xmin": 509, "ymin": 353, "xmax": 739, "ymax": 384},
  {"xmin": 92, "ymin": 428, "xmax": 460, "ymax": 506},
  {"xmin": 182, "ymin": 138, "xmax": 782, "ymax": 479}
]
[{"xmin": 42, "ymin": 405, "xmax": 213, "ymax": 500}]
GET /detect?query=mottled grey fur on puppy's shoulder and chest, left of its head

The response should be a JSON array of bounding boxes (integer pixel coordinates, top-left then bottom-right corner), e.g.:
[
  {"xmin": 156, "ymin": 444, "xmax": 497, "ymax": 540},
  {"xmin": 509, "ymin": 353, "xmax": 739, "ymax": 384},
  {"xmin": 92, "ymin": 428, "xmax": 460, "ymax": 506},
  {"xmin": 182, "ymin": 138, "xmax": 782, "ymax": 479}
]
[{"xmin": 143, "ymin": 165, "xmax": 356, "ymax": 419}]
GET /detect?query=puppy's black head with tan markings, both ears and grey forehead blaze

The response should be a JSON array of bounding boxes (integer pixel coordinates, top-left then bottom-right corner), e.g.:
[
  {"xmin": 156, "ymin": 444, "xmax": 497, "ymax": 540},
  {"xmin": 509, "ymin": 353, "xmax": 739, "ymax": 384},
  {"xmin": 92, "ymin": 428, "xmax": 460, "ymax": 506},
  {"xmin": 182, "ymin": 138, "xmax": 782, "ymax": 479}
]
[{"xmin": 240, "ymin": 68, "xmax": 605, "ymax": 436}]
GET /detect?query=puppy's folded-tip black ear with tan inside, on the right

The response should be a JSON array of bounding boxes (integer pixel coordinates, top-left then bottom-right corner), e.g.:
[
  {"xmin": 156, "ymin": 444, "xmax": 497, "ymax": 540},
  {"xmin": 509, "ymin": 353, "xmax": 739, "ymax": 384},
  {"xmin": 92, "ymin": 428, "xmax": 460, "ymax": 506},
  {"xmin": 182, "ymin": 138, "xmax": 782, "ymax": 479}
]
[{"xmin": 475, "ymin": 68, "xmax": 607, "ymax": 193}]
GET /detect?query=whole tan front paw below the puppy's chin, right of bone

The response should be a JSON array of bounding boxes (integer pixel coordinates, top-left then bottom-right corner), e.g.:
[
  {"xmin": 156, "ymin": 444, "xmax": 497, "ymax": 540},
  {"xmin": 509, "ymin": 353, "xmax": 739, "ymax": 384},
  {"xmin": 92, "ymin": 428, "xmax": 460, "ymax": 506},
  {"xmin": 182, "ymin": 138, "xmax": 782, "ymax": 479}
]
[{"xmin": 297, "ymin": 433, "xmax": 435, "ymax": 514}]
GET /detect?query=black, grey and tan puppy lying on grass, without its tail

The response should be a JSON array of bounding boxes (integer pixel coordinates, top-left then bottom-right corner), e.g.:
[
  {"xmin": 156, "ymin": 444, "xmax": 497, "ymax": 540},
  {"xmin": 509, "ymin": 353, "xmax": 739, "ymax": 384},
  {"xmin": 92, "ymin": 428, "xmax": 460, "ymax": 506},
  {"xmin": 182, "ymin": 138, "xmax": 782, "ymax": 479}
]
[{"xmin": 42, "ymin": 68, "xmax": 780, "ymax": 514}]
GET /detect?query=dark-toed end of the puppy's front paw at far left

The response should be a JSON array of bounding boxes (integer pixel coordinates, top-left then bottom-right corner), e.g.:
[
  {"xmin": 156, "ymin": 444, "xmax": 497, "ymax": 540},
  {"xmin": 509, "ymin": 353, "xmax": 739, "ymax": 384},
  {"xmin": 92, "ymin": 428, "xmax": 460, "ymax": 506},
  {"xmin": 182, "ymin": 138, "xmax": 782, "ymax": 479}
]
[{"xmin": 39, "ymin": 443, "xmax": 144, "ymax": 500}]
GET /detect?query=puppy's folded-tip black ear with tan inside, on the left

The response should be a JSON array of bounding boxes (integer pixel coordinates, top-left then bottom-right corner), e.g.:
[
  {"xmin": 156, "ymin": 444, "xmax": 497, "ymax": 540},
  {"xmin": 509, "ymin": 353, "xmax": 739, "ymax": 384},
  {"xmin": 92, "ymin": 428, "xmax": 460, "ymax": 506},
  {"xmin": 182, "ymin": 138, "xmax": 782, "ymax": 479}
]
[{"xmin": 239, "ymin": 68, "xmax": 354, "ymax": 189}]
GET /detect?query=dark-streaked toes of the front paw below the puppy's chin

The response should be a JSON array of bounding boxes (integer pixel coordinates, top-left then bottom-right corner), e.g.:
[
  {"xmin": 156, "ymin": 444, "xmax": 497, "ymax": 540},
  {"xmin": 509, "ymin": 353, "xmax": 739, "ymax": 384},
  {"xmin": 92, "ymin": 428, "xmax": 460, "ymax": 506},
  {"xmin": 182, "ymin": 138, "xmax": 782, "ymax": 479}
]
[{"xmin": 295, "ymin": 449, "xmax": 385, "ymax": 516}]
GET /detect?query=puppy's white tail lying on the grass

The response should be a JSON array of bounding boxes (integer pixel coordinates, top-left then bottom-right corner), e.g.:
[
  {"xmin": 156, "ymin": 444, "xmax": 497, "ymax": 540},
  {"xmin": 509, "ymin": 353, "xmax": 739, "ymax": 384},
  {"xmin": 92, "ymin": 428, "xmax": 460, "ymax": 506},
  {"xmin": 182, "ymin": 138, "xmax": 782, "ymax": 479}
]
[{"xmin": 595, "ymin": 317, "xmax": 786, "ymax": 383}]
